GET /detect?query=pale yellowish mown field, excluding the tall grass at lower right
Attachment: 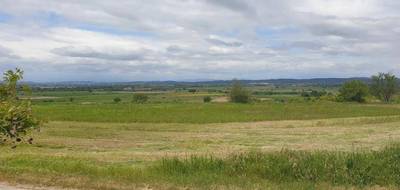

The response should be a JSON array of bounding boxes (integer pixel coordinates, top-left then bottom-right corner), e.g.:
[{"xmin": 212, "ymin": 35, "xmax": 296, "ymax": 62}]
[{"xmin": 0, "ymin": 116, "xmax": 400, "ymax": 189}]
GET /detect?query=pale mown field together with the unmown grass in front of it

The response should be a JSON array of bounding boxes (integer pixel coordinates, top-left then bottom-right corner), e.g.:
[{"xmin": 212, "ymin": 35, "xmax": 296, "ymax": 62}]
[{"xmin": 0, "ymin": 116, "xmax": 400, "ymax": 189}]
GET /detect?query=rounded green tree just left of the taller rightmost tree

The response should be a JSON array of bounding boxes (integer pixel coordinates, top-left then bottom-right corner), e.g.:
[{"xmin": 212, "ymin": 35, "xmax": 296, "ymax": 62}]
[{"xmin": 339, "ymin": 80, "xmax": 369, "ymax": 102}]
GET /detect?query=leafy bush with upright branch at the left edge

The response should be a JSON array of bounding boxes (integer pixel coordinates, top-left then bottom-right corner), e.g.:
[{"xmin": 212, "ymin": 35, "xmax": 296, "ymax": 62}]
[{"xmin": 0, "ymin": 69, "xmax": 40, "ymax": 143}]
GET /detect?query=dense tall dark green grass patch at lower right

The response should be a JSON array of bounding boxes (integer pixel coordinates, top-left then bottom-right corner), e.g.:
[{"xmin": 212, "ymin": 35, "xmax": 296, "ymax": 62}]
[{"xmin": 153, "ymin": 145, "xmax": 400, "ymax": 187}]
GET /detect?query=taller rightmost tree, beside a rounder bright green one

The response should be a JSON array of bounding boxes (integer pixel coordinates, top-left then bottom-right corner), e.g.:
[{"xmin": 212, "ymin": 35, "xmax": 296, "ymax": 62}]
[{"xmin": 371, "ymin": 73, "xmax": 397, "ymax": 102}]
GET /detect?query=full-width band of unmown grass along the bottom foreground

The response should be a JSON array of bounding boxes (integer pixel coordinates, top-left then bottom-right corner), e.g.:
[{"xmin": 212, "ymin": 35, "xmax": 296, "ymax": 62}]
[{"xmin": 0, "ymin": 145, "xmax": 400, "ymax": 189}]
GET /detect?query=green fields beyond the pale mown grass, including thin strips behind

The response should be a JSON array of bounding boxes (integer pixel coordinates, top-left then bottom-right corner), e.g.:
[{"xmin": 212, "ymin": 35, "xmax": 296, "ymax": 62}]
[{"xmin": 28, "ymin": 92, "xmax": 400, "ymax": 123}]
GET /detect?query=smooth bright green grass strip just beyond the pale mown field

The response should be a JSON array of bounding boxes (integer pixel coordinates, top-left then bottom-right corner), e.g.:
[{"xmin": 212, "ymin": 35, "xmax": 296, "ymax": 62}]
[{"xmin": 34, "ymin": 101, "xmax": 400, "ymax": 123}]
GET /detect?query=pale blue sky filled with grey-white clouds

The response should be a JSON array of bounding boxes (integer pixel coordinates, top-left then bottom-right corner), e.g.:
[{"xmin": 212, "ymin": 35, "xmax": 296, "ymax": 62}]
[{"xmin": 0, "ymin": 0, "xmax": 400, "ymax": 82}]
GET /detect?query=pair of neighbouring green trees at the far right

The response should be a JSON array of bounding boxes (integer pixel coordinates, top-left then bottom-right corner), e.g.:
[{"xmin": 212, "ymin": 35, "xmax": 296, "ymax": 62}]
[{"xmin": 338, "ymin": 73, "xmax": 398, "ymax": 103}]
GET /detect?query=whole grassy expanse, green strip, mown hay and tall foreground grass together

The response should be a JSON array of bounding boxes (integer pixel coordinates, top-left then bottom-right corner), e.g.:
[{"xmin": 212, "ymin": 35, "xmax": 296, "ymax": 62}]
[{"xmin": 0, "ymin": 92, "xmax": 400, "ymax": 189}]
